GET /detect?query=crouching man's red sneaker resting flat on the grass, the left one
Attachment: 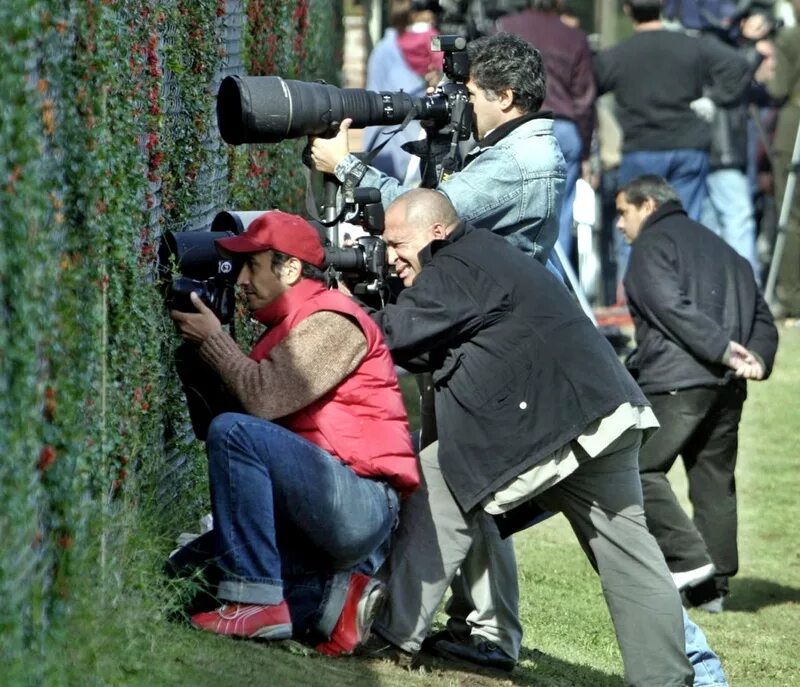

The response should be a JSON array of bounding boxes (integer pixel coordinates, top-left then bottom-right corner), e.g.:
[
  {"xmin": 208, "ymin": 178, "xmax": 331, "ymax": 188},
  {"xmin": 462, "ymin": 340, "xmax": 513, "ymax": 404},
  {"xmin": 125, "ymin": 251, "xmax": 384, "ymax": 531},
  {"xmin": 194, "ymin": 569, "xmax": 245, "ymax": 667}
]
[{"xmin": 192, "ymin": 601, "xmax": 292, "ymax": 639}]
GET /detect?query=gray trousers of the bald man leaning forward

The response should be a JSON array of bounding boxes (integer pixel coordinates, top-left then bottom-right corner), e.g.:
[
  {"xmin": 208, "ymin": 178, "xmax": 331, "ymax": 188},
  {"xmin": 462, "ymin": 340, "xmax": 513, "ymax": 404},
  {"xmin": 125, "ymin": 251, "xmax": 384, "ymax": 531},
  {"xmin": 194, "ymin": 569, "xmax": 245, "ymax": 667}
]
[{"xmin": 375, "ymin": 430, "xmax": 693, "ymax": 687}]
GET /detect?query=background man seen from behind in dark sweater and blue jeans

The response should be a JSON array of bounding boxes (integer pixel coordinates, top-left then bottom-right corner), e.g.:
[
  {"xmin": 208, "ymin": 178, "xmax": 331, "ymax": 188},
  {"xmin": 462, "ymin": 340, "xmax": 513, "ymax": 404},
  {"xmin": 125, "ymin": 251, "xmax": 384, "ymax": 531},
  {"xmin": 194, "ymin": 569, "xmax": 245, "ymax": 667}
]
[{"xmin": 594, "ymin": 0, "xmax": 751, "ymax": 220}]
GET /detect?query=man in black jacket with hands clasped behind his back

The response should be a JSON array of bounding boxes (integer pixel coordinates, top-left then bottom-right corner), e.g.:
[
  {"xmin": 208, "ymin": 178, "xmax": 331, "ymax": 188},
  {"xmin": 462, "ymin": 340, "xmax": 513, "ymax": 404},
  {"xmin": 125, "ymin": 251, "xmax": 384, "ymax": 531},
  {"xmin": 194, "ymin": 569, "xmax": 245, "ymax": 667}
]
[{"xmin": 617, "ymin": 175, "xmax": 778, "ymax": 611}]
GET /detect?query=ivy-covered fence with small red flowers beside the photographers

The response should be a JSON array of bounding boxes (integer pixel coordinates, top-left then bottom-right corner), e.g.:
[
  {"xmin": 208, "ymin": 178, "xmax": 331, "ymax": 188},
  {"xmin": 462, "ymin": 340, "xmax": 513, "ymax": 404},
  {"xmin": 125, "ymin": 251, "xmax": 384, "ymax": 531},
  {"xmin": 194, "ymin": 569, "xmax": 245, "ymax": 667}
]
[{"xmin": 0, "ymin": 0, "xmax": 342, "ymax": 677}]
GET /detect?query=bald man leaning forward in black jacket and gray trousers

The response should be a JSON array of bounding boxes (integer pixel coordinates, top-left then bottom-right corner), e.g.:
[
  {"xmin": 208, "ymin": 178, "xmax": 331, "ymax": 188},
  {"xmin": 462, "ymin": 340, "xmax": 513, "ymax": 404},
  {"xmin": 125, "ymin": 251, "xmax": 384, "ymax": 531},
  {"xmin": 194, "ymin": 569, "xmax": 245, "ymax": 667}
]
[{"xmin": 364, "ymin": 189, "xmax": 693, "ymax": 685}]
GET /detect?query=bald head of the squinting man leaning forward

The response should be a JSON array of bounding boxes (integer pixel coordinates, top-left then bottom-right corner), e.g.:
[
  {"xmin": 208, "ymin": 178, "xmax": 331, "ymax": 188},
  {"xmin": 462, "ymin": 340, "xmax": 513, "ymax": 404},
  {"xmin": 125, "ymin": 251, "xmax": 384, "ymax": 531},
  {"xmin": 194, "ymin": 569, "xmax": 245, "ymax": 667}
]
[{"xmin": 383, "ymin": 188, "xmax": 458, "ymax": 286}]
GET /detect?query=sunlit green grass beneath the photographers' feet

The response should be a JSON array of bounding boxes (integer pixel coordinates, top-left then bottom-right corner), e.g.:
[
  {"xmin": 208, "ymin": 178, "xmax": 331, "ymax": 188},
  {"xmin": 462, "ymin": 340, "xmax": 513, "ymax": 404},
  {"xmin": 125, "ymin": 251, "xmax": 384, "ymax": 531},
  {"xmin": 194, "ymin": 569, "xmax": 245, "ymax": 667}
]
[{"xmin": 50, "ymin": 328, "xmax": 800, "ymax": 687}]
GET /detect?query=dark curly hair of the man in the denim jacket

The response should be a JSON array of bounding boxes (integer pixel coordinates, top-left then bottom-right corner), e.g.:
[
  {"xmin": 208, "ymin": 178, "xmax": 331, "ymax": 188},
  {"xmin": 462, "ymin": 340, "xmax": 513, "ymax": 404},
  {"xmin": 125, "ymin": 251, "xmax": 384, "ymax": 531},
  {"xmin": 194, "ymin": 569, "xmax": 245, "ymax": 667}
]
[{"xmin": 467, "ymin": 33, "xmax": 546, "ymax": 113}]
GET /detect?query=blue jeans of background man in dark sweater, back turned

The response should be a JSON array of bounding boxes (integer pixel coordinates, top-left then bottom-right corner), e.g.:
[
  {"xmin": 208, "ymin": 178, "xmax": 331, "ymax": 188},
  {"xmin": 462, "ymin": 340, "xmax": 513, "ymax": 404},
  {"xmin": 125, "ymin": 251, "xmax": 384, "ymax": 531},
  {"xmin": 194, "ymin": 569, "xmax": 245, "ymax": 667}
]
[{"xmin": 619, "ymin": 148, "xmax": 708, "ymax": 222}]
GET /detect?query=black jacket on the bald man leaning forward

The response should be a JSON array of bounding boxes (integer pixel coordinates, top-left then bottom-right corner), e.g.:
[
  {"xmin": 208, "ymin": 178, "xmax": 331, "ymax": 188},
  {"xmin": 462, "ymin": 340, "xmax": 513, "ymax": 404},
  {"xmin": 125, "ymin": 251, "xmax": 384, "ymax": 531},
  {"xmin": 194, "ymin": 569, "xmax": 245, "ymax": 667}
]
[{"xmin": 374, "ymin": 223, "xmax": 647, "ymax": 511}]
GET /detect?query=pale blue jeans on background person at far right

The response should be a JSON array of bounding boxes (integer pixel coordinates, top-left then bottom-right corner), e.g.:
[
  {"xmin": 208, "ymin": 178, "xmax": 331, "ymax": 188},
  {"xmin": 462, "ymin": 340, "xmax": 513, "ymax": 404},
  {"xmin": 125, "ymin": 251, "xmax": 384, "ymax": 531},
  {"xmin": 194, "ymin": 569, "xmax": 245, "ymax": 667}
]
[{"xmin": 701, "ymin": 169, "xmax": 760, "ymax": 281}]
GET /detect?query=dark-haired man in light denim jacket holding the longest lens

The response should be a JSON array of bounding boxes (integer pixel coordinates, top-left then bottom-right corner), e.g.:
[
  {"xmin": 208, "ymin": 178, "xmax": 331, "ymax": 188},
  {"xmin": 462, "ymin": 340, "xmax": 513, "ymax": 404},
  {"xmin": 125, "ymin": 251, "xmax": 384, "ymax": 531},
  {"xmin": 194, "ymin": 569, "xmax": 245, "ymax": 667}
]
[{"xmin": 311, "ymin": 33, "xmax": 566, "ymax": 262}]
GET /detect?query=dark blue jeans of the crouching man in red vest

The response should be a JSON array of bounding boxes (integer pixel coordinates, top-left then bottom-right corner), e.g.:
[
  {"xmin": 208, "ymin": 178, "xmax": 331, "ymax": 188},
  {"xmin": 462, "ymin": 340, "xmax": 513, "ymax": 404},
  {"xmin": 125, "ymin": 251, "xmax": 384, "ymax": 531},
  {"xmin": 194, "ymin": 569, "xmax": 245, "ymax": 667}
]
[{"xmin": 206, "ymin": 413, "xmax": 398, "ymax": 632}]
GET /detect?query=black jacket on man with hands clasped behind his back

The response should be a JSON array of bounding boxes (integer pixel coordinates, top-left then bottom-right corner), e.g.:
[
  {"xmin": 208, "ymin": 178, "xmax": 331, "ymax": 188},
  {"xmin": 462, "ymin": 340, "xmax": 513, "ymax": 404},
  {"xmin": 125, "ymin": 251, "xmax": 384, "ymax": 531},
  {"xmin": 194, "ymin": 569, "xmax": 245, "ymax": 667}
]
[{"xmin": 624, "ymin": 202, "xmax": 778, "ymax": 393}]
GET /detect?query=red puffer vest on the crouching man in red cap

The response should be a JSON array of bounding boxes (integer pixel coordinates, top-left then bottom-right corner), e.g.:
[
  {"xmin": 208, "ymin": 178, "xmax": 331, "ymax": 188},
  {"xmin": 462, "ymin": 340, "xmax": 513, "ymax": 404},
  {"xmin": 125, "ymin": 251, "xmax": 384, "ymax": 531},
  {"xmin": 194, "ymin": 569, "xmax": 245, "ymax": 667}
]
[{"xmin": 250, "ymin": 279, "xmax": 419, "ymax": 496}]
